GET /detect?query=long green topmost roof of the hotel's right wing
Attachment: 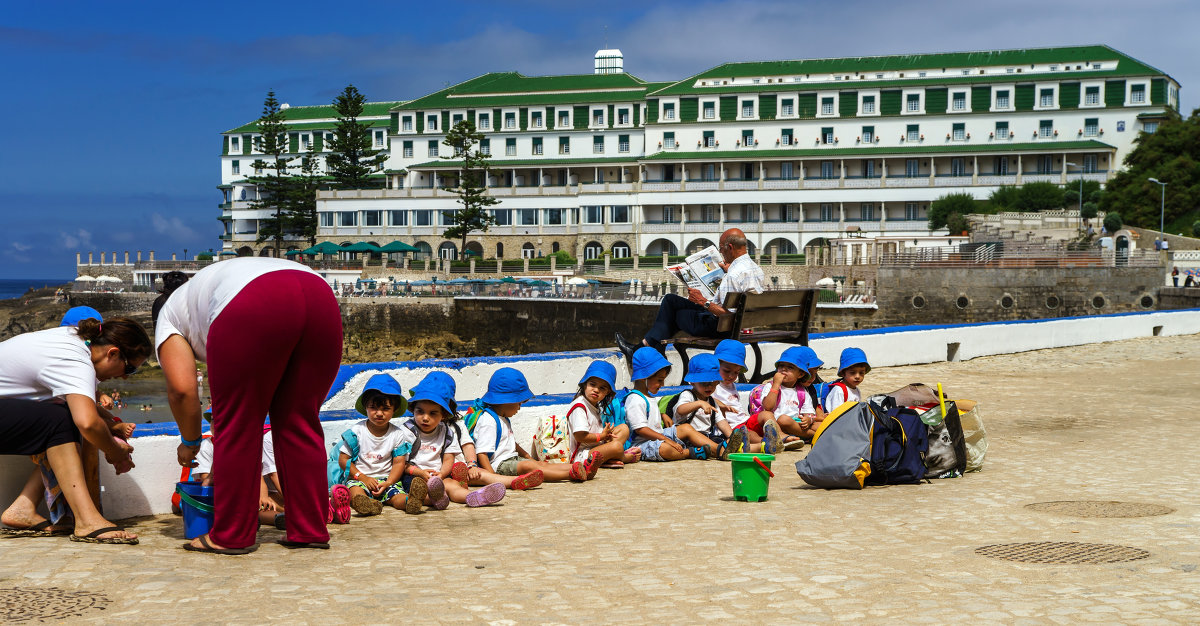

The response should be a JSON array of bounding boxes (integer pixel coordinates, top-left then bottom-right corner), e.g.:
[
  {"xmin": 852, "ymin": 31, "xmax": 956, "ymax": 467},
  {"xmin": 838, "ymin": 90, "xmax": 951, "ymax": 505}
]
[{"xmin": 650, "ymin": 46, "xmax": 1165, "ymax": 96}]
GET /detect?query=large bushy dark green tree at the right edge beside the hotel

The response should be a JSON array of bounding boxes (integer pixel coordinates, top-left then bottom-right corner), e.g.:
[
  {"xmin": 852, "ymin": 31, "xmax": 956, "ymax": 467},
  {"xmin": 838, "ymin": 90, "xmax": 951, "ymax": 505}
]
[{"xmin": 1100, "ymin": 109, "xmax": 1200, "ymax": 230}]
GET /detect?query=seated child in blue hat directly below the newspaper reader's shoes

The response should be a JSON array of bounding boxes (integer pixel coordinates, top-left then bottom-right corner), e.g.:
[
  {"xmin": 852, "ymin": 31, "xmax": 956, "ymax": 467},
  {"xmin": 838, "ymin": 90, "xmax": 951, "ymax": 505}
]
[{"xmin": 625, "ymin": 345, "xmax": 692, "ymax": 461}]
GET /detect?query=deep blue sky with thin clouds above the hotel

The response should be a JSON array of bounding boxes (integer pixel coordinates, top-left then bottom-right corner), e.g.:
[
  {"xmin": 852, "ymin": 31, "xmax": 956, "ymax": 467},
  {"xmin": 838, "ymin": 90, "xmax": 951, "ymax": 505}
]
[{"xmin": 0, "ymin": 0, "xmax": 1200, "ymax": 278}]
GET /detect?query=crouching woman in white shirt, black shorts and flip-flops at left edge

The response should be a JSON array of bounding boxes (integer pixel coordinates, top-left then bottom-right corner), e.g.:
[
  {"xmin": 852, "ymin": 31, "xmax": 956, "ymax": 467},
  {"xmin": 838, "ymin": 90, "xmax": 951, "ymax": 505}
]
[{"xmin": 0, "ymin": 318, "xmax": 151, "ymax": 543}]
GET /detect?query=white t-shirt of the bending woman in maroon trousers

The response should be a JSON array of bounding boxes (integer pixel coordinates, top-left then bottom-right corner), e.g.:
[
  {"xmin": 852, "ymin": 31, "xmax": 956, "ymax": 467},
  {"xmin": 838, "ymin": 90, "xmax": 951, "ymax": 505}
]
[{"xmin": 154, "ymin": 257, "xmax": 317, "ymax": 362}]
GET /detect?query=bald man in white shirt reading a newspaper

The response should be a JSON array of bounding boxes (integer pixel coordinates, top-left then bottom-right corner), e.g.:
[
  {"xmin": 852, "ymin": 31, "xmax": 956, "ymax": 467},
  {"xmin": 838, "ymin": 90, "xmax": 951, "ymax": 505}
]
[{"xmin": 617, "ymin": 228, "xmax": 767, "ymax": 359}]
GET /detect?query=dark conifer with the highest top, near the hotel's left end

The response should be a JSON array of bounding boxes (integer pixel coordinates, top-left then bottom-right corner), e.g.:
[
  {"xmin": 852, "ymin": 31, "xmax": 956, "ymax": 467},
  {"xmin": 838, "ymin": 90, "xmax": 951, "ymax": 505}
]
[{"xmin": 325, "ymin": 85, "xmax": 388, "ymax": 189}]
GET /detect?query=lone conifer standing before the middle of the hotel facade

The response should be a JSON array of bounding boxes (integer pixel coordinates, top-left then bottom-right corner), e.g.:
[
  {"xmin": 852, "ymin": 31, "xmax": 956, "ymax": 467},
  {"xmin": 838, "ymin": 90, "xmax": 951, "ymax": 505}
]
[{"xmin": 442, "ymin": 120, "xmax": 499, "ymax": 251}]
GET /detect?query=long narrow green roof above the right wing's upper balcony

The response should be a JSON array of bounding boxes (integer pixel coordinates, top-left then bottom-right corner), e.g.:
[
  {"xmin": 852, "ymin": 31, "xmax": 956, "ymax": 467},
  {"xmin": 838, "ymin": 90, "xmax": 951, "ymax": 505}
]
[{"xmin": 640, "ymin": 140, "xmax": 1116, "ymax": 161}]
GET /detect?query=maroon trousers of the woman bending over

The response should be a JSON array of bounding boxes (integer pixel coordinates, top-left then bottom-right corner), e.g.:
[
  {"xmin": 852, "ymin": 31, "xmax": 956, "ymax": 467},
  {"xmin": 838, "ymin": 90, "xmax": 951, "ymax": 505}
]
[{"xmin": 208, "ymin": 270, "xmax": 342, "ymax": 548}]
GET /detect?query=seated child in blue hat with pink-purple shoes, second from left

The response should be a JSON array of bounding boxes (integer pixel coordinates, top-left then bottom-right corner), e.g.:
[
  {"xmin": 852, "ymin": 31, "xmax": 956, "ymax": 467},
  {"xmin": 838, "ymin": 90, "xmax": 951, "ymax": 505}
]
[{"xmin": 401, "ymin": 372, "xmax": 505, "ymax": 511}]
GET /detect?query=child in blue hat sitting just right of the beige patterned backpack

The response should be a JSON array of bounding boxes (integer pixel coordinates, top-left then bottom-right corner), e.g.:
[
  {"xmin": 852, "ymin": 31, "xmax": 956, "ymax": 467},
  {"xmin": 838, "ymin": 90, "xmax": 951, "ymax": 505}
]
[{"xmin": 566, "ymin": 361, "xmax": 642, "ymax": 478}]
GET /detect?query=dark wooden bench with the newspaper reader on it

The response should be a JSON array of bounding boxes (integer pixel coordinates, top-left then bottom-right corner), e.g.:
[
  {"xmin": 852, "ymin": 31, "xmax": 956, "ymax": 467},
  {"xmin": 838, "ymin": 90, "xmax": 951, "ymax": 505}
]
[{"xmin": 668, "ymin": 289, "xmax": 817, "ymax": 385}]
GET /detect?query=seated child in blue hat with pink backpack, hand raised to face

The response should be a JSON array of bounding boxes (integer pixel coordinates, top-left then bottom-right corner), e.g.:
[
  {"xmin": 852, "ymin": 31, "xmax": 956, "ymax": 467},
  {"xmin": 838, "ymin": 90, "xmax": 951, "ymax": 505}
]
[{"xmin": 750, "ymin": 347, "xmax": 816, "ymax": 441}]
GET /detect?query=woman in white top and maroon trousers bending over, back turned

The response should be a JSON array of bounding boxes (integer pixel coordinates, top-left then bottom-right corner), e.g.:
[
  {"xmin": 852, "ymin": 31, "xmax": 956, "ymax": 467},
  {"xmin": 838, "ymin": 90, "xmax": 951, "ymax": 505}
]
[{"xmin": 152, "ymin": 257, "xmax": 342, "ymax": 554}]
